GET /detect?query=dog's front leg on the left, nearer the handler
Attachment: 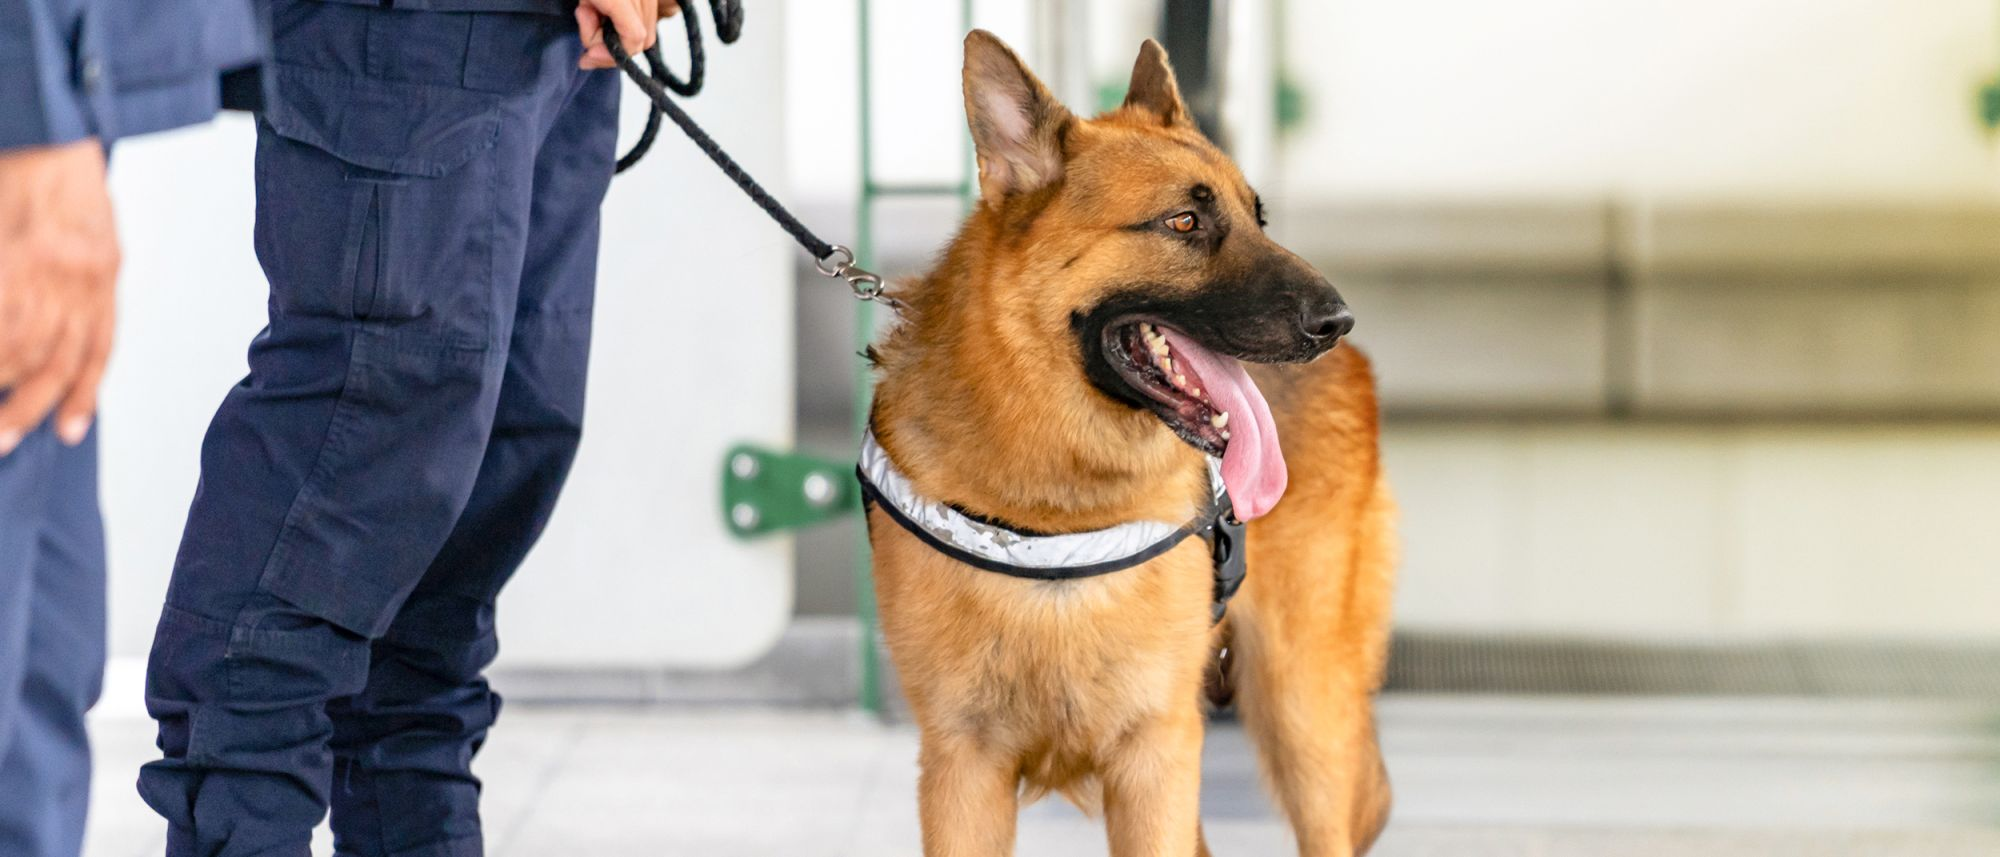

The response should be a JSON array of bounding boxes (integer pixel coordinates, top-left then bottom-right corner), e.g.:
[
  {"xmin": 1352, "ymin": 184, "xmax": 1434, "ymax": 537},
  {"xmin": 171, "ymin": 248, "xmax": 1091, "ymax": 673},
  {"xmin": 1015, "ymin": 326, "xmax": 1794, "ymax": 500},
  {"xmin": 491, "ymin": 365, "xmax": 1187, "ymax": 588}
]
[{"xmin": 916, "ymin": 733, "xmax": 1020, "ymax": 857}]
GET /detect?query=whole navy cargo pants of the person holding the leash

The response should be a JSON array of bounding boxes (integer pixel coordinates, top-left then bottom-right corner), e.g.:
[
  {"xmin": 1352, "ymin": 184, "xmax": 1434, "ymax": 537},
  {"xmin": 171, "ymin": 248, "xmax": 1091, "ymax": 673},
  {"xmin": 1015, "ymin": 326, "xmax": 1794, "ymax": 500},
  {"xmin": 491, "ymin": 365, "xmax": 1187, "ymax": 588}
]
[{"xmin": 140, "ymin": 0, "xmax": 618, "ymax": 857}]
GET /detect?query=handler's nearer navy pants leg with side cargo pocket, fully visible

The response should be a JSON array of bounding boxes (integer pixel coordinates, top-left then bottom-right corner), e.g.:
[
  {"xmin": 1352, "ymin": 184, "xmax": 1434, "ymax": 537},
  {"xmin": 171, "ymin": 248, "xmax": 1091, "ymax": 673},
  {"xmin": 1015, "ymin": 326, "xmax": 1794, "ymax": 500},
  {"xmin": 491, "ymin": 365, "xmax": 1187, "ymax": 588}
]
[{"xmin": 140, "ymin": 0, "xmax": 604, "ymax": 857}]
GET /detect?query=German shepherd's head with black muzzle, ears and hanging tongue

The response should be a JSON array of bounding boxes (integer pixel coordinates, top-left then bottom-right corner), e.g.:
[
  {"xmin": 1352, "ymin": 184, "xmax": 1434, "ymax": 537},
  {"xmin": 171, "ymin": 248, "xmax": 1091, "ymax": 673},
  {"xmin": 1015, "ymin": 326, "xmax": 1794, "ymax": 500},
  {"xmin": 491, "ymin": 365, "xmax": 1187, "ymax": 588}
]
[{"xmin": 884, "ymin": 30, "xmax": 1354, "ymax": 517}]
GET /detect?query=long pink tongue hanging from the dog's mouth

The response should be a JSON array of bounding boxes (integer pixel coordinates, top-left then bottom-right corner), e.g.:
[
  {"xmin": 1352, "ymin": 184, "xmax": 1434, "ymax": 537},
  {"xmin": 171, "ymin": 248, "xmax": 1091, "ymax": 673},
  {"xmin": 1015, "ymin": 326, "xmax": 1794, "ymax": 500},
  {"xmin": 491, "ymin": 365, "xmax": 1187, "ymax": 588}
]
[{"xmin": 1160, "ymin": 328, "xmax": 1286, "ymax": 521}]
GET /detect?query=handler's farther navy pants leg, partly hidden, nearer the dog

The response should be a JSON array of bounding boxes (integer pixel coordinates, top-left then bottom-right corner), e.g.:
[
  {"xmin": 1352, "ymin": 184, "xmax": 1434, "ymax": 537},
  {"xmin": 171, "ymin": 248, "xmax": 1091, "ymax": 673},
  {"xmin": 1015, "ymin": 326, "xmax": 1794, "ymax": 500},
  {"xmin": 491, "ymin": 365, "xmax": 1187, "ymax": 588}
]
[{"xmin": 330, "ymin": 67, "xmax": 618, "ymax": 857}]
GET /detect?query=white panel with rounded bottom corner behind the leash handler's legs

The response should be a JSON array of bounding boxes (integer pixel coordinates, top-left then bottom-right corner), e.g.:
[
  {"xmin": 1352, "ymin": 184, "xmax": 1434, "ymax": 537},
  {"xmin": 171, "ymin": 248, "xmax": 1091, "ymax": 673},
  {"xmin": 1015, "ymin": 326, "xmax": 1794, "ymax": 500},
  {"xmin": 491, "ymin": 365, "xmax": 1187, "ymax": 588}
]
[{"xmin": 102, "ymin": 16, "xmax": 798, "ymax": 667}]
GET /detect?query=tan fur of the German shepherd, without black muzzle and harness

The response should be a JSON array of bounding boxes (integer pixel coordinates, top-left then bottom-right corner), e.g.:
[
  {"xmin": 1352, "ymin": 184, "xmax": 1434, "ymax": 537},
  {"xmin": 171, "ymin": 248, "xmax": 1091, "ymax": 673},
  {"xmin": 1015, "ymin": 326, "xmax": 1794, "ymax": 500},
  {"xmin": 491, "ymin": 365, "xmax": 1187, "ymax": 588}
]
[{"xmin": 868, "ymin": 34, "xmax": 1394, "ymax": 857}]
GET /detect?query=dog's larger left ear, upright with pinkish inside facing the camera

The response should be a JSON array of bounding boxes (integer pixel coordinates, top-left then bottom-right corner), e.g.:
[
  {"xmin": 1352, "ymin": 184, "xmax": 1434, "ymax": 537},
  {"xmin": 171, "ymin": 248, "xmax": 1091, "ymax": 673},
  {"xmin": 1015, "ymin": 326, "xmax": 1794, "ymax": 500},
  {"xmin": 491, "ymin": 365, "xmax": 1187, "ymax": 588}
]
[{"xmin": 966, "ymin": 30, "xmax": 1074, "ymax": 200}]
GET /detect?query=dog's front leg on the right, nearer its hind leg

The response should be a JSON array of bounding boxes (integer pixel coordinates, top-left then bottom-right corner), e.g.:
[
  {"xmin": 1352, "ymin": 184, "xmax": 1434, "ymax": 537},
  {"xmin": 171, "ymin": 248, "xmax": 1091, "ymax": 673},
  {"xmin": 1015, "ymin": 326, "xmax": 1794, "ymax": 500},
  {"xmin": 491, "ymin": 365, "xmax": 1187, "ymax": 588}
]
[{"xmin": 1102, "ymin": 708, "xmax": 1206, "ymax": 857}]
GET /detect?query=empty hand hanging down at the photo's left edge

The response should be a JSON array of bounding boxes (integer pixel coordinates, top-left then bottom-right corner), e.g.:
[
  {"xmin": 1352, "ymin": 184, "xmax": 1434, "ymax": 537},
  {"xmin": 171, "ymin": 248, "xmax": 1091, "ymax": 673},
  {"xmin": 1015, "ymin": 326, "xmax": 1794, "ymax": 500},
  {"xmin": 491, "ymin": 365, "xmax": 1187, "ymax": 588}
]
[{"xmin": 0, "ymin": 140, "xmax": 120, "ymax": 455}]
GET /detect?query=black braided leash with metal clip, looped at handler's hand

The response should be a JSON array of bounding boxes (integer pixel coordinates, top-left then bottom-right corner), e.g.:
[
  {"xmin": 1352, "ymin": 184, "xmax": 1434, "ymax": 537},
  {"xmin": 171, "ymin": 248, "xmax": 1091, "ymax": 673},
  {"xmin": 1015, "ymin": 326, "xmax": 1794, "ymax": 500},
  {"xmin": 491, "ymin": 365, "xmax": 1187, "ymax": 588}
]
[{"xmin": 604, "ymin": 0, "xmax": 898, "ymax": 306}]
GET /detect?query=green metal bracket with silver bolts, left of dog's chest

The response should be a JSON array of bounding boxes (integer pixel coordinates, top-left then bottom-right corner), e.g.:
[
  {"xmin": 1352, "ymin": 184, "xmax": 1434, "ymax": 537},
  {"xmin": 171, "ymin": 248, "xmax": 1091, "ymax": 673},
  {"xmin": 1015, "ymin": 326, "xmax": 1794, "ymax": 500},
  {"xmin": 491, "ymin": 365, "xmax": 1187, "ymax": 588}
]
[{"xmin": 722, "ymin": 445, "xmax": 862, "ymax": 539}]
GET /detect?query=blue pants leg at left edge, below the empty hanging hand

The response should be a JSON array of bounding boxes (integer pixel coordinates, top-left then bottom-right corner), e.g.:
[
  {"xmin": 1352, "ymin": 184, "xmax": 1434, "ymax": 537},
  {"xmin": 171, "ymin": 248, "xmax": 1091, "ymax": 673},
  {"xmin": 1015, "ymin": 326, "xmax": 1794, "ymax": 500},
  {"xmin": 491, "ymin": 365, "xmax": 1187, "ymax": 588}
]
[{"xmin": 0, "ymin": 426, "xmax": 104, "ymax": 857}]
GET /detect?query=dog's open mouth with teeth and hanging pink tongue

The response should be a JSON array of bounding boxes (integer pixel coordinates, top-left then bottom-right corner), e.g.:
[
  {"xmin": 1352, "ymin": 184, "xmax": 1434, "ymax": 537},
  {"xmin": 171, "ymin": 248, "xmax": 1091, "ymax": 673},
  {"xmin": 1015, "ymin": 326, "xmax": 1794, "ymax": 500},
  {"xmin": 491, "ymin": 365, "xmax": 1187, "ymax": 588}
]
[{"xmin": 1102, "ymin": 318, "xmax": 1288, "ymax": 521}]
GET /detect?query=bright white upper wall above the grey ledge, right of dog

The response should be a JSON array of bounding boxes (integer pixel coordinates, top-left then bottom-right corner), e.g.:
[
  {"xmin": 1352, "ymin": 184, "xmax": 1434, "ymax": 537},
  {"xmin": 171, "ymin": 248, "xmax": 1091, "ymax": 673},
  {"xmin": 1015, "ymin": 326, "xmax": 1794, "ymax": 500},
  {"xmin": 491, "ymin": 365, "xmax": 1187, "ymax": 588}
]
[{"xmin": 1284, "ymin": 0, "xmax": 2000, "ymax": 200}]
